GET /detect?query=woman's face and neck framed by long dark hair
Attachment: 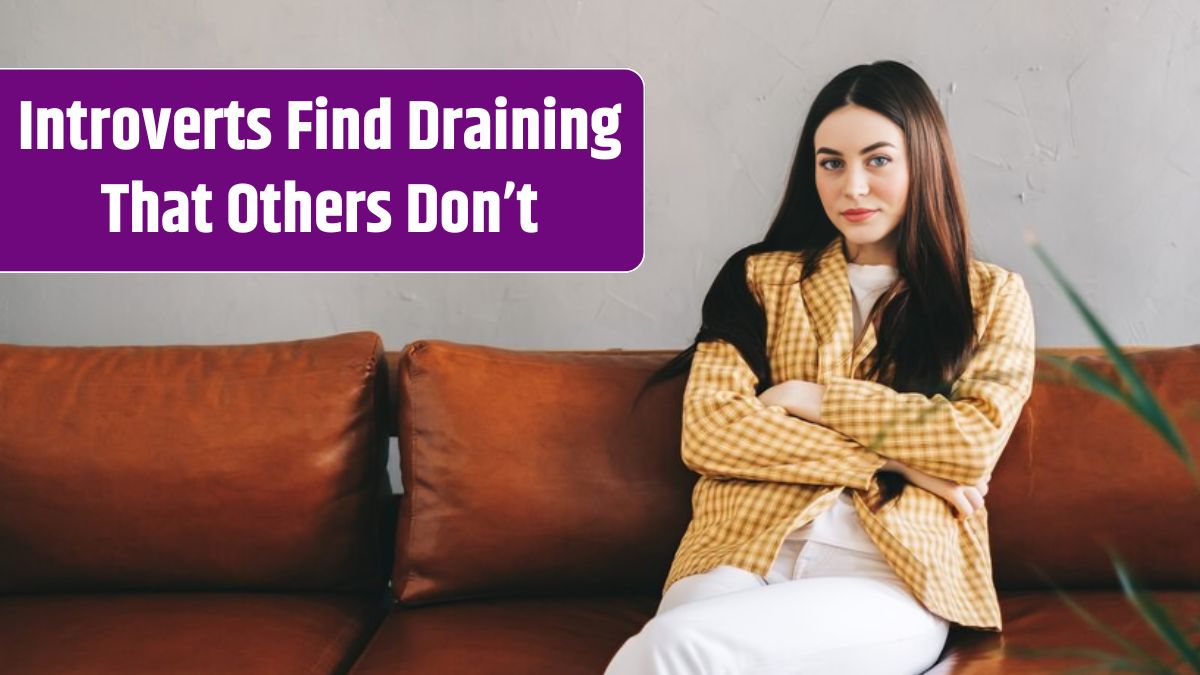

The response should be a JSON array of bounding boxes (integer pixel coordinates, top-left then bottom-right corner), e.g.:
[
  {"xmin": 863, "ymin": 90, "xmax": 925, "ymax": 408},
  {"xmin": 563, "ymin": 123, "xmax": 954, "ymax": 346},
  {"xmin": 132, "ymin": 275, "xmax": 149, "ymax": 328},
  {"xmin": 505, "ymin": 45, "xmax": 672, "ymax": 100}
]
[{"xmin": 814, "ymin": 104, "xmax": 908, "ymax": 265}]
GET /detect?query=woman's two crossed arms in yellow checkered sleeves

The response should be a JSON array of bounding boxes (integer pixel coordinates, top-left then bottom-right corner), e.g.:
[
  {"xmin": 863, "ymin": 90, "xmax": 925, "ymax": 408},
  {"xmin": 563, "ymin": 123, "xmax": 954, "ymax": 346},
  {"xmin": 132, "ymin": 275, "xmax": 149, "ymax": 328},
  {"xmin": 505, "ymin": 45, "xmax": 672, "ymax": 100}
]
[{"xmin": 682, "ymin": 274, "xmax": 1034, "ymax": 490}]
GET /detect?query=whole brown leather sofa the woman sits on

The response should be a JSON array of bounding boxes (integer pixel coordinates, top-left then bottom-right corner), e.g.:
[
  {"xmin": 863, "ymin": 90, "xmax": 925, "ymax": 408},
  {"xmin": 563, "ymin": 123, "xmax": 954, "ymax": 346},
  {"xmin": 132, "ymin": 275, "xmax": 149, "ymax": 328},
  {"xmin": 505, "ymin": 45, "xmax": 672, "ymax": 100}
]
[{"xmin": 0, "ymin": 333, "xmax": 1200, "ymax": 675}]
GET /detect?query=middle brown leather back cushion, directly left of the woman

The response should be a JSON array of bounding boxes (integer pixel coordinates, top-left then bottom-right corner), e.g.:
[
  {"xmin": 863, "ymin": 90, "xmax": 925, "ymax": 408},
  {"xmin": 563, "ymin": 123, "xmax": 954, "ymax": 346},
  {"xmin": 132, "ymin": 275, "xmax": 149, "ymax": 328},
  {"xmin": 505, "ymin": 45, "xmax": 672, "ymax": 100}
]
[{"xmin": 392, "ymin": 340, "xmax": 696, "ymax": 604}]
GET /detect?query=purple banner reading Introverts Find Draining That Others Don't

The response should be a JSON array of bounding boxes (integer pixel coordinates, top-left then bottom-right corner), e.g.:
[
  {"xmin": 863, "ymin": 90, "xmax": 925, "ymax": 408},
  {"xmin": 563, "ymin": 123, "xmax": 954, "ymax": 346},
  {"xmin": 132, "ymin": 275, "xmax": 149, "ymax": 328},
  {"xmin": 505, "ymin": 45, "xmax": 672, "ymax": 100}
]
[{"xmin": 0, "ymin": 70, "xmax": 646, "ymax": 271}]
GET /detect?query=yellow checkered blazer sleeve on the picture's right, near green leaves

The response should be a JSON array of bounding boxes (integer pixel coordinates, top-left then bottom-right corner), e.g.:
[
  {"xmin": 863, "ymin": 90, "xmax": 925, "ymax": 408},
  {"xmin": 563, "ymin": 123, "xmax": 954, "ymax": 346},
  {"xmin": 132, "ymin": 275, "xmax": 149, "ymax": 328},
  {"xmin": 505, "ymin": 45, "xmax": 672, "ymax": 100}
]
[{"xmin": 821, "ymin": 273, "xmax": 1036, "ymax": 484}]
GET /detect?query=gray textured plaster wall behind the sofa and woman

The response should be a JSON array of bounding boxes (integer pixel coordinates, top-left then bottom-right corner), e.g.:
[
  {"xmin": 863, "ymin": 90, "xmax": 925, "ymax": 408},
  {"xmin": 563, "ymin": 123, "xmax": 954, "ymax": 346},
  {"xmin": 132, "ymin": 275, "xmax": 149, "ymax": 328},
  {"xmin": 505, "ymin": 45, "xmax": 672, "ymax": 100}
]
[{"xmin": 0, "ymin": 0, "xmax": 1200, "ymax": 348}]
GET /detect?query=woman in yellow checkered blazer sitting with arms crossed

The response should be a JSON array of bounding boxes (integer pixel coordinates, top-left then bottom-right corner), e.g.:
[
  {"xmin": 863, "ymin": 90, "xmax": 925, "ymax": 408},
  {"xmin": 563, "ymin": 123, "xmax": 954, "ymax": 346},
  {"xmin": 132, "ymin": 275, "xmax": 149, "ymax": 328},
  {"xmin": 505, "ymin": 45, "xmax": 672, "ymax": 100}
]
[{"xmin": 607, "ymin": 61, "xmax": 1034, "ymax": 675}]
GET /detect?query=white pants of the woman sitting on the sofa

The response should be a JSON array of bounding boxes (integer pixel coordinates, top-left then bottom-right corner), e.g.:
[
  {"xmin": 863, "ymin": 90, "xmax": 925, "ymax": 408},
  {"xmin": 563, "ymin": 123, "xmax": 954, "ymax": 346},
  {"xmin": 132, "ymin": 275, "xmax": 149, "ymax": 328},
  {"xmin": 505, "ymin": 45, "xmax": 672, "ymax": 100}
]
[{"xmin": 605, "ymin": 539, "xmax": 949, "ymax": 675}]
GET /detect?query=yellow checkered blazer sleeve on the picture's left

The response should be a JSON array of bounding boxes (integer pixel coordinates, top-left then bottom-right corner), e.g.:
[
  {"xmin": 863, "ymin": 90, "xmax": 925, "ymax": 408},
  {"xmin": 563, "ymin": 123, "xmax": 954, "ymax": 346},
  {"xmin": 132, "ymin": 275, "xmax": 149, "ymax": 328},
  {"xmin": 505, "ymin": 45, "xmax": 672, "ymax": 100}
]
[{"xmin": 682, "ymin": 331, "xmax": 887, "ymax": 490}]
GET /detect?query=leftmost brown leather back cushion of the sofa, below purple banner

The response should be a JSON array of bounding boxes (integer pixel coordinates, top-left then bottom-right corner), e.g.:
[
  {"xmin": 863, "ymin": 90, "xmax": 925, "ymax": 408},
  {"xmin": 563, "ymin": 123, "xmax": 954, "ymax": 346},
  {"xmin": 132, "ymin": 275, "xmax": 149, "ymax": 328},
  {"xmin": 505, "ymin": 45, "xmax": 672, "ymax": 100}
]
[{"xmin": 0, "ymin": 333, "xmax": 388, "ymax": 592}]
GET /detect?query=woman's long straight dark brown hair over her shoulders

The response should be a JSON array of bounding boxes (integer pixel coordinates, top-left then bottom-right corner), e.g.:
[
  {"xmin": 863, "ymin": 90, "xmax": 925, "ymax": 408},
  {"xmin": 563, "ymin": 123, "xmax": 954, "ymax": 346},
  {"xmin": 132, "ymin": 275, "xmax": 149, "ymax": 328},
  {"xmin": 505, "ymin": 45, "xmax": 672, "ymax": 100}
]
[{"xmin": 638, "ymin": 61, "xmax": 976, "ymax": 508}]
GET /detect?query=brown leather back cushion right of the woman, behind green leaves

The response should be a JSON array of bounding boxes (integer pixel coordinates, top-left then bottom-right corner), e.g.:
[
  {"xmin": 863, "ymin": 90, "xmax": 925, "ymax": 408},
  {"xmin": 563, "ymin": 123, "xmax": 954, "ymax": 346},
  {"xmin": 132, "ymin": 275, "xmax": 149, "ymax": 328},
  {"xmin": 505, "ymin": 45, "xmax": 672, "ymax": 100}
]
[{"xmin": 986, "ymin": 345, "xmax": 1200, "ymax": 589}]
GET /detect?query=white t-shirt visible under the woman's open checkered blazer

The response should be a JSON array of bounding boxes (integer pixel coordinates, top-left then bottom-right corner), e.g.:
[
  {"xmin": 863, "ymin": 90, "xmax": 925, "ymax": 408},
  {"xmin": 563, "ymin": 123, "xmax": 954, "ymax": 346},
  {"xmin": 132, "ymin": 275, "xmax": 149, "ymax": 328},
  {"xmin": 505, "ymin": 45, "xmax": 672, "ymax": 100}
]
[{"xmin": 787, "ymin": 258, "xmax": 900, "ymax": 555}]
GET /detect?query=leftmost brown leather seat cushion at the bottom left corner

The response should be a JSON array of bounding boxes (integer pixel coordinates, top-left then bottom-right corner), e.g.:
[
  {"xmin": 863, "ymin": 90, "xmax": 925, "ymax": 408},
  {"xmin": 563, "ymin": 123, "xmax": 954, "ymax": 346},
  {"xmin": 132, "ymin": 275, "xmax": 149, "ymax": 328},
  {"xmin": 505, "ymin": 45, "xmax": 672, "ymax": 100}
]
[{"xmin": 0, "ymin": 591, "xmax": 390, "ymax": 675}]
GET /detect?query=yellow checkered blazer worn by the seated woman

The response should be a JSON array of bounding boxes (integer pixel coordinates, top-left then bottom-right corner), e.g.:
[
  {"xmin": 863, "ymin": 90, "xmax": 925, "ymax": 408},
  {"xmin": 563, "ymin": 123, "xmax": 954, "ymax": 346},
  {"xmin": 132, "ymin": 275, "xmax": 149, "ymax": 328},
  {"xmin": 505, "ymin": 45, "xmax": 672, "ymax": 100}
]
[{"xmin": 662, "ymin": 237, "xmax": 1034, "ymax": 631}]
